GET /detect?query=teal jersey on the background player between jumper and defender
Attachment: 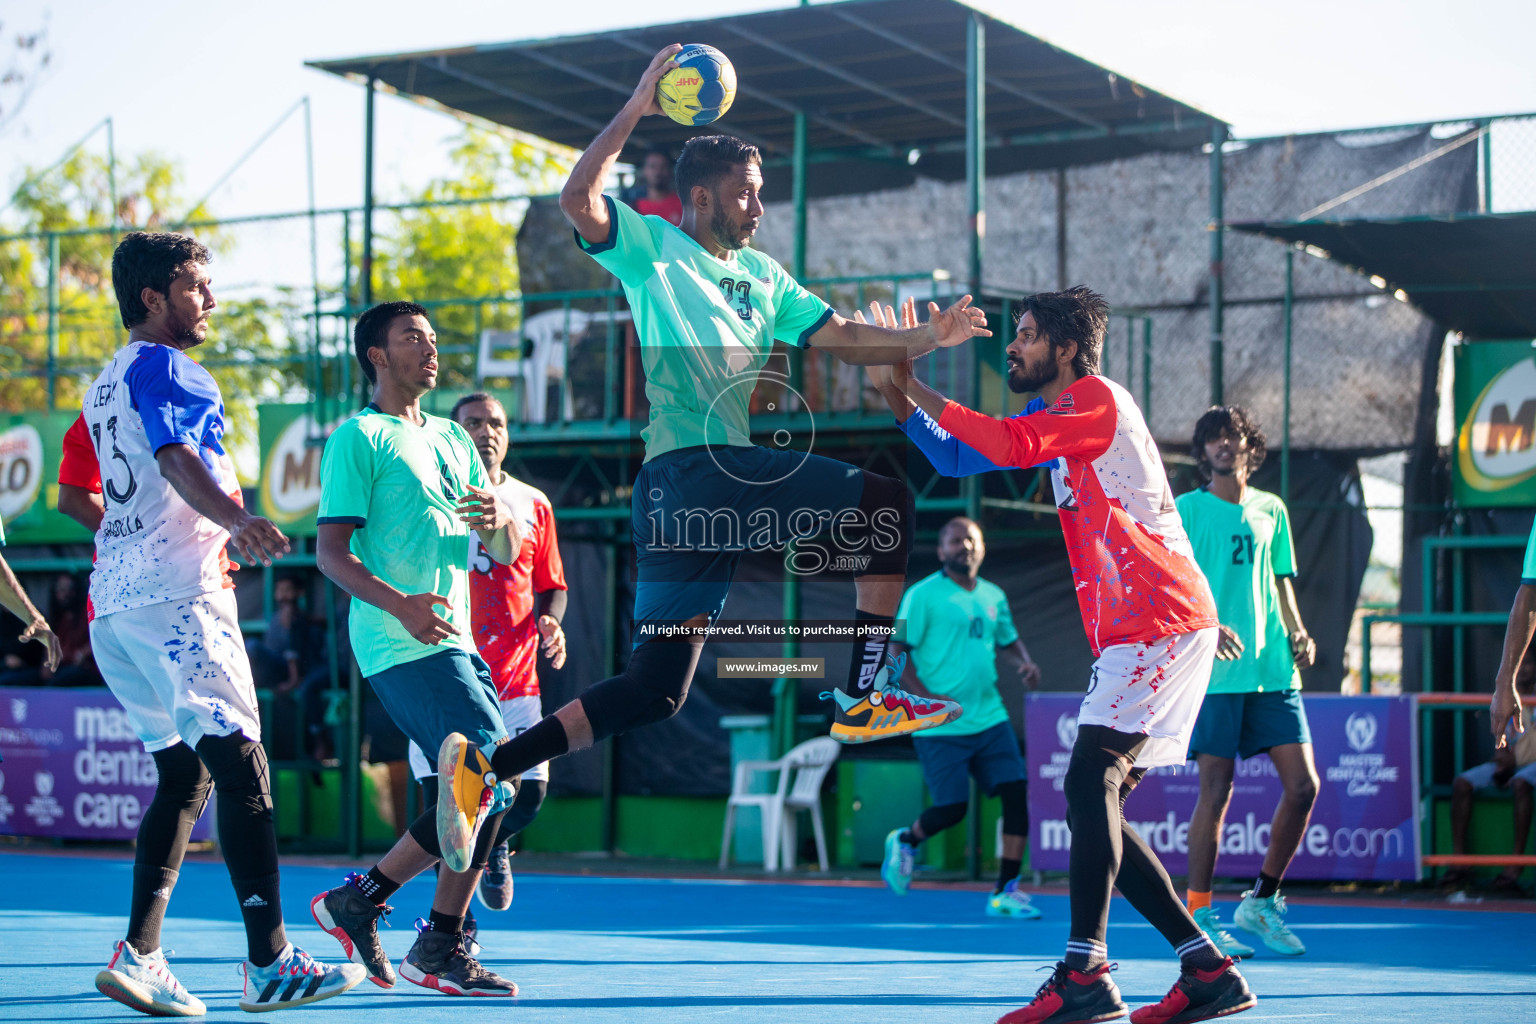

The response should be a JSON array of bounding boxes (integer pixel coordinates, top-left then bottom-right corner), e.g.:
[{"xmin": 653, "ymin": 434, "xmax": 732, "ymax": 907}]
[{"xmin": 895, "ymin": 571, "xmax": 1018, "ymax": 735}]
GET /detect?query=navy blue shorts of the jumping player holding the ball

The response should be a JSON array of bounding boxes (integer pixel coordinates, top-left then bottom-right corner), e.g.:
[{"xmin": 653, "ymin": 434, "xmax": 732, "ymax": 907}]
[{"xmin": 630, "ymin": 445, "xmax": 863, "ymax": 646}]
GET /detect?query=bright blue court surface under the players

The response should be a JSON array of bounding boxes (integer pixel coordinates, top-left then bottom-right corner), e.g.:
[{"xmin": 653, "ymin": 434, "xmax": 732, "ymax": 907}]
[{"xmin": 0, "ymin": 854, "xmax": 1536, "ymax": 1024}]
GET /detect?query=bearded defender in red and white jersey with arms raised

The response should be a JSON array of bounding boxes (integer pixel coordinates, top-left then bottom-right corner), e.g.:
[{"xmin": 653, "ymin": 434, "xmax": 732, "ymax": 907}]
[{"xmin": 871, "ymin": 287, "xmax": 1256, "ymax": 1024}]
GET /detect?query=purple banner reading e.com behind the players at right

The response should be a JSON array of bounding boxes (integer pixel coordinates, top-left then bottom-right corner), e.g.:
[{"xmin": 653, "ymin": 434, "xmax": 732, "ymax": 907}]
[{"xmin": 1025, "ymin": 694, "xmax": 1419, "ymax": 881}]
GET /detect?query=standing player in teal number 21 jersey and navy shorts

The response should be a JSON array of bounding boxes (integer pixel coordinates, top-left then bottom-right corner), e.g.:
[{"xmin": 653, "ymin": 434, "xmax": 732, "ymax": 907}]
[{"xmin": 1177, "ymin": 405, "xmax": 1318, "ymax": 956}]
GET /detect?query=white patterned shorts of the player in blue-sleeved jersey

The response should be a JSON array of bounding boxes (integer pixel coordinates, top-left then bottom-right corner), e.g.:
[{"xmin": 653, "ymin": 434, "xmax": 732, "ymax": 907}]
[{"xmin": 91, "ymin": 590, "xmax": 261, "ymax": 754}]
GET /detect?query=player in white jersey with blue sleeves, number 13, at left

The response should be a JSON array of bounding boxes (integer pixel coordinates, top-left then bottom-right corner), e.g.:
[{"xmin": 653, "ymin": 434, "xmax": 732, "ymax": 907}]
[{"xmin": 83, "ymin": 232, "xmax": 366, "ymax": 1016}]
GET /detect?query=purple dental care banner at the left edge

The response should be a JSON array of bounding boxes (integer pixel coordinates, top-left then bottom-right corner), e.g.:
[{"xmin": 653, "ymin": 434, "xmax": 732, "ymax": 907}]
[{"xmin": 0, "ymin": 686, "xmax": 212, "ymax": 840}]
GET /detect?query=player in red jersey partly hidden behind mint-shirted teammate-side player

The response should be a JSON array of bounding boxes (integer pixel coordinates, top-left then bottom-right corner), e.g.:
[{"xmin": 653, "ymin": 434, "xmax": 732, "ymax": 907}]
[{"xmin": 410, "ymin": 391, "xmax": 565, "ymax": 933}]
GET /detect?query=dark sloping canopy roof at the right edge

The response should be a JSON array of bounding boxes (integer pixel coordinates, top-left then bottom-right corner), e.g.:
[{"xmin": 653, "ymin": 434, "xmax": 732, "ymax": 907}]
[{"xmin": 1227, "ymin": 213, "xmax": 1536, "ymax": 338}]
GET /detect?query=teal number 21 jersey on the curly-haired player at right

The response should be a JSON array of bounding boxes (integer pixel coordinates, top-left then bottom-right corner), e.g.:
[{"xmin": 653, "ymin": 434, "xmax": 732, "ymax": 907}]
[{"xmin": 1175, "ymin": 487, "xmax": 1301, "ymax": 694}]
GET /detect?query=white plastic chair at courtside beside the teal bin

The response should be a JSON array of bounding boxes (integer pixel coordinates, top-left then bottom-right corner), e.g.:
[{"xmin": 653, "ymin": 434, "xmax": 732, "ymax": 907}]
[{"xmin": 720, "ymin": 735, "xmax": 842, "ymax": 872}]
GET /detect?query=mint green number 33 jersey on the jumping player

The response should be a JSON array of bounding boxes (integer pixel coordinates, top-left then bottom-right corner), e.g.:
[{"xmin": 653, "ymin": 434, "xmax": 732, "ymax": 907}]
[{"xmin": 576, "ymin": 197, "xmax": 833, "ymax": 461}]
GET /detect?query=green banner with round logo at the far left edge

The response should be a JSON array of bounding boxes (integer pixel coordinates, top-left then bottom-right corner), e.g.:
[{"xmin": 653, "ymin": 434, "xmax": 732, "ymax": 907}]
[{"xmin": 0, "ymin": 408, "xmax": 91, "ymax": 547}]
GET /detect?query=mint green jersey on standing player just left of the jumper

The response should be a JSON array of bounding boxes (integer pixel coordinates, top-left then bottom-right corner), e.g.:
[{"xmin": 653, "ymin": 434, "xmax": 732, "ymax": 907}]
[{"xmin": 316, "ymin": 405, "xmax": 490, "ymax": 676}]
